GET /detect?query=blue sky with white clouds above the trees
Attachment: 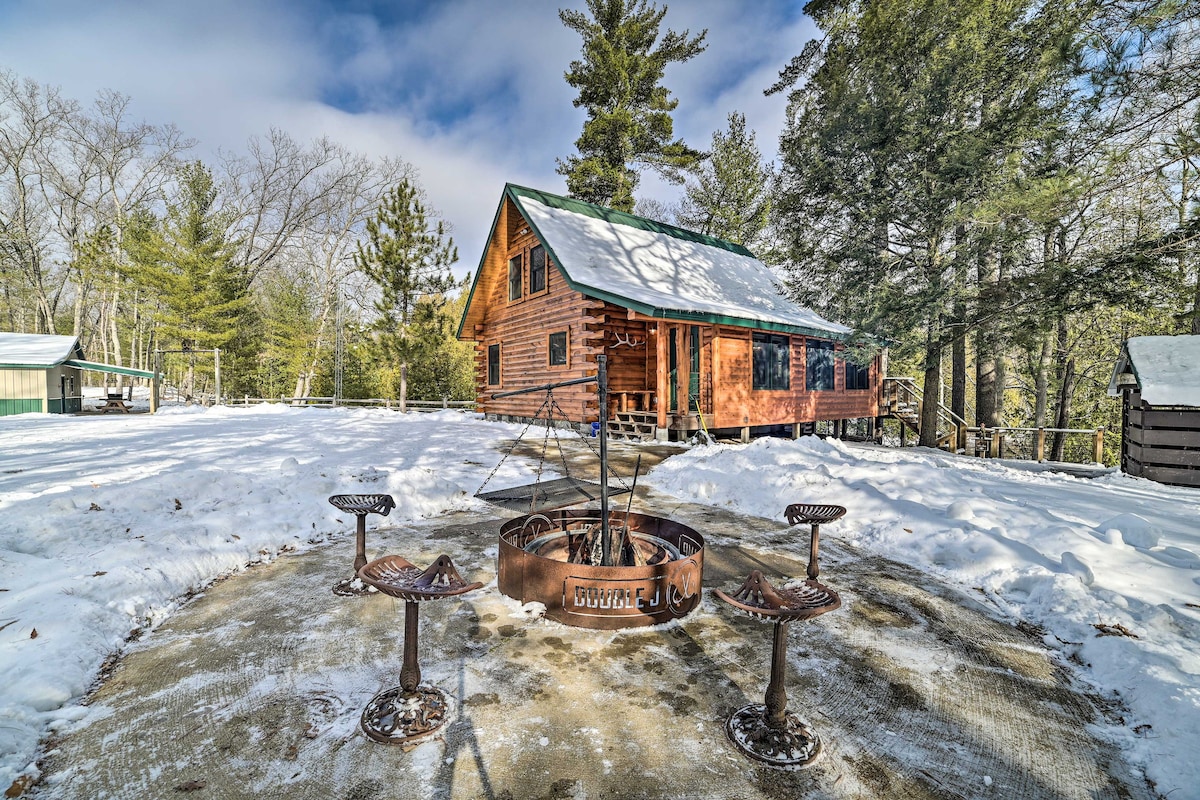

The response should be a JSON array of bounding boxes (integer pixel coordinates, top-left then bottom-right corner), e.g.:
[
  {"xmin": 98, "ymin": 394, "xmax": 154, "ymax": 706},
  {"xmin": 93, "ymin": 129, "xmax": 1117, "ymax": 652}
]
[{"xmin": 0, "ymin": 0, "xmax": 815, "ymax": 269}]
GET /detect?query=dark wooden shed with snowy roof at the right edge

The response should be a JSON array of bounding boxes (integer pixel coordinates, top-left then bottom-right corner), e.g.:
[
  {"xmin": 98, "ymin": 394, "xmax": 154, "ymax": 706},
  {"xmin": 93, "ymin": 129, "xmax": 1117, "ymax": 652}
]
[{"xmin": 1109, "ymin": 336, "xmax": 1200, "ymax": 487}]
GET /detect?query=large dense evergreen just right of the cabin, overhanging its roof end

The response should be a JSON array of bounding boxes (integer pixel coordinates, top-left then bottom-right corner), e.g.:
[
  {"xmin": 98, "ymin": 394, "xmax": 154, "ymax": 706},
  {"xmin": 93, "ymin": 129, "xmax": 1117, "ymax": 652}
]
[{"xmin": 772, "ymin": 0, "xmax": 1081, "ymax": 445}]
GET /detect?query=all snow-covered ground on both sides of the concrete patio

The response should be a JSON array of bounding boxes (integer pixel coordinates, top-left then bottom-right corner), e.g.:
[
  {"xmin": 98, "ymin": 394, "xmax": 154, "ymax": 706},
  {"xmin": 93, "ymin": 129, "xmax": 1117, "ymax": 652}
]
[{"xmin": 0, "ymin": 405, "xmax": 1200, "ymax": 800}]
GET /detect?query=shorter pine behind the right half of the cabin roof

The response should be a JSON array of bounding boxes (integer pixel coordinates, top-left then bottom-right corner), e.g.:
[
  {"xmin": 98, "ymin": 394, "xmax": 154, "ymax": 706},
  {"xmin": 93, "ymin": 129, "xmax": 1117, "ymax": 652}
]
[{"xmin": 677, "ymin": 112, "xmax": 774, "ymax": 251}]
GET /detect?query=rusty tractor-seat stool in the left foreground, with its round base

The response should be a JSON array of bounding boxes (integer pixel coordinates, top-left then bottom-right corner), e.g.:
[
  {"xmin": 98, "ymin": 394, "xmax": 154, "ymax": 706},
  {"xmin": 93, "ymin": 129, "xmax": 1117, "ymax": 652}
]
[{"xmin": 359, "ymin": 555, "xmax": 484, "ymax": 747}]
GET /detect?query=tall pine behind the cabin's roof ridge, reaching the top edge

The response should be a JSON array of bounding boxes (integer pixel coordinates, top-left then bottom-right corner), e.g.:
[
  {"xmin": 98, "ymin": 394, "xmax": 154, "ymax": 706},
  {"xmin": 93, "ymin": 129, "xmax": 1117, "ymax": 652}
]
[{"xmin": 558, "ymin": 0, "xmax": 708, "ymax": 211}]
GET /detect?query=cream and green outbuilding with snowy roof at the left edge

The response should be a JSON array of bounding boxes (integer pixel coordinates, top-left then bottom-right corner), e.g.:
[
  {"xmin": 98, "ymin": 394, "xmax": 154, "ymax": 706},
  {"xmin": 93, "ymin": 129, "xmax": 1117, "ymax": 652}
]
[{"xmin": 0, "ymin": 332, "xmax": 154, "ymax": 416}]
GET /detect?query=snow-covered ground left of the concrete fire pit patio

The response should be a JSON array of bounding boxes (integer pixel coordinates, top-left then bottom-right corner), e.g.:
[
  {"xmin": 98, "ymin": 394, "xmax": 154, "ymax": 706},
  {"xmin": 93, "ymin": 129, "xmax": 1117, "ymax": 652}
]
[{"xmin": 0, "ymin": 405, "xmax": 535, "ymax": 788}]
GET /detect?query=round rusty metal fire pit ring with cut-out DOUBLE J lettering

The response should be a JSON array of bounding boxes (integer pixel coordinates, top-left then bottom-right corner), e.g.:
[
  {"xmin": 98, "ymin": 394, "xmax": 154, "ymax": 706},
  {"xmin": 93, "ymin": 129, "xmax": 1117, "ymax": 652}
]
[{"xmin": 497, "ymin": 509, "xmax": 704, "ymax": 631}]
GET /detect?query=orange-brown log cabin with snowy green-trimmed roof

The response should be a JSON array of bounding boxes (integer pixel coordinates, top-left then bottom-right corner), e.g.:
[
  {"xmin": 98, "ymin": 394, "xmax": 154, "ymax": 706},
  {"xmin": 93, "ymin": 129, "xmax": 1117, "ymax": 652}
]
[{"xmin": 458, "ymin": 184, "xmax": 882, "ymax": 440}]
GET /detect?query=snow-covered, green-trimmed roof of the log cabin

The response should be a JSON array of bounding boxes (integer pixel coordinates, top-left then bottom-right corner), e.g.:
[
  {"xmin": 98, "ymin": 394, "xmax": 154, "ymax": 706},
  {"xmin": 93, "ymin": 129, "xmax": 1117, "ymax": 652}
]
[{"xmin": 509, "ymin": 186, "xmax": 852, "ymax": 338}]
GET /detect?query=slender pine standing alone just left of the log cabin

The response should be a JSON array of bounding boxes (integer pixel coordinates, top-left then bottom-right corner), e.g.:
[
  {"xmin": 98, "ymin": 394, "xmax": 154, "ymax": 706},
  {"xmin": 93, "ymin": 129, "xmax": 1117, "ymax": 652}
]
[{"xmin": 355, "ymin": 180, "xmax": 458, "ymax": 404}]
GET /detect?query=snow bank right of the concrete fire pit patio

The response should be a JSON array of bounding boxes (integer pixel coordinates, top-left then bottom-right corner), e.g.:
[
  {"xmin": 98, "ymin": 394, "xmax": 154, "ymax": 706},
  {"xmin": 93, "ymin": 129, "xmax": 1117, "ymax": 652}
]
[{"xmin": 644, "ymin": 438, "xmax": 1200, "ymax": 798}]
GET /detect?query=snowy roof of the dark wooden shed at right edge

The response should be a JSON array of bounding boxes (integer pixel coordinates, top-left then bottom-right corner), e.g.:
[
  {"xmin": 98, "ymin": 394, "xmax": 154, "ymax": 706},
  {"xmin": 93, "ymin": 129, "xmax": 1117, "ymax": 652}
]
[{"xmin": 1110, "ymin": 336, "xmax": 1200, "ymax": 407}]
